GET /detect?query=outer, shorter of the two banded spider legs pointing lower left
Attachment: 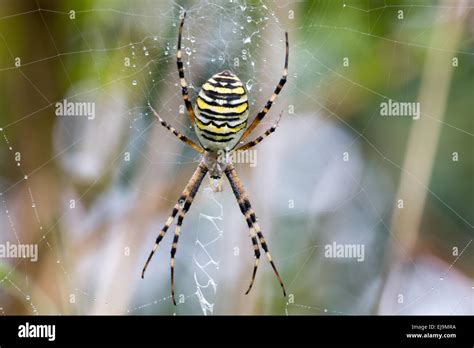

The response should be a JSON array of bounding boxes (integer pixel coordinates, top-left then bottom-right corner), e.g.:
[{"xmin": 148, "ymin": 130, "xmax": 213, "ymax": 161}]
[{"xmin": 142, "ymin": 163, "xmax": 207, "ymax": 278}]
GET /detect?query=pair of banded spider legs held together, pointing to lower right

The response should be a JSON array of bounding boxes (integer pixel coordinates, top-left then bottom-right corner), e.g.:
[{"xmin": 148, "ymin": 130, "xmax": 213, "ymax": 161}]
[{"xmin": 225, "ymin": 164, "xmax": 286, "ymax": 296}]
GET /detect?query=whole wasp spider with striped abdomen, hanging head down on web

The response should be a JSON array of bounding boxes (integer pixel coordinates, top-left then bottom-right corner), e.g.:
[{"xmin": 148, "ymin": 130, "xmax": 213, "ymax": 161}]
[{"xmin": 142, "ymin": 14, "xmax": 289, "ymax": 305}]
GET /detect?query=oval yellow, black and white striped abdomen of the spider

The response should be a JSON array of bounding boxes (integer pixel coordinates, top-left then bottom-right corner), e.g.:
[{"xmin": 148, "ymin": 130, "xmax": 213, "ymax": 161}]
[{"xmin": 194, "ymin": 70, "xmax": 249, "ymax": 152}]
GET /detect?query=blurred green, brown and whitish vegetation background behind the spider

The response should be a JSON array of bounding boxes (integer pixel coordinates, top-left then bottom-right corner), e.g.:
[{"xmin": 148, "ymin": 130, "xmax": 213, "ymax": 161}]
[{"xmin": 0, "ymin": 0, "xmax": 474, "ymax": 315}]
